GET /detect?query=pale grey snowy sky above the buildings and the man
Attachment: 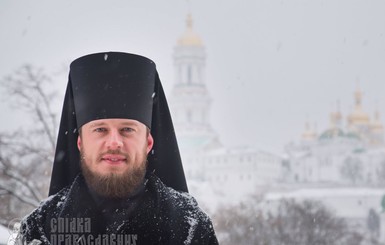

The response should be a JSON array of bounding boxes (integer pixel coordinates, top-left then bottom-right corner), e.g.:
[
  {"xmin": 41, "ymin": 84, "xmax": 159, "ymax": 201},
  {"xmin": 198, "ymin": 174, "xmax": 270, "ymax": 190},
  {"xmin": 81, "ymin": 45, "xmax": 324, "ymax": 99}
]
[{"xmin": 0, "ymin": 0, "xmax": 385, "ymax": 153}]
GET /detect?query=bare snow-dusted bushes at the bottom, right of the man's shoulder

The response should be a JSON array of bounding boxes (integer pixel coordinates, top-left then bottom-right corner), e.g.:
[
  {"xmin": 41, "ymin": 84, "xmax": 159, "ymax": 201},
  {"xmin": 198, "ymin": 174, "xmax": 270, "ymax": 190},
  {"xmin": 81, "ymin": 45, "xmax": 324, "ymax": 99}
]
[{"xmin": 213, "ymin": 197, "xmax": 363, "ymax": 245}]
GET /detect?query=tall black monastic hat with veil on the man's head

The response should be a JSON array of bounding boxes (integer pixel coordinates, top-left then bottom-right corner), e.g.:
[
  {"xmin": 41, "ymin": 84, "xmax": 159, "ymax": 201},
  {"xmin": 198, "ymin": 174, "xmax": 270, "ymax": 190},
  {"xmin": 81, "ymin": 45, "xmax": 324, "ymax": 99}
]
[{"xmin": 49, "ymin": 52, "xmax": 187, "ymax": 195}]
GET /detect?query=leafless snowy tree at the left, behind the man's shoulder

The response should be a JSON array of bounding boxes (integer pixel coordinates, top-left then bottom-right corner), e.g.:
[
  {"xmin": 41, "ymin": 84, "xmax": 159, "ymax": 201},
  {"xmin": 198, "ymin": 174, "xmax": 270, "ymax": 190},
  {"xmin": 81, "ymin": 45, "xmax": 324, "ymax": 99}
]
[{"xmin": 0, "ymin": 65, "xmax": 57, "ymax": 223}]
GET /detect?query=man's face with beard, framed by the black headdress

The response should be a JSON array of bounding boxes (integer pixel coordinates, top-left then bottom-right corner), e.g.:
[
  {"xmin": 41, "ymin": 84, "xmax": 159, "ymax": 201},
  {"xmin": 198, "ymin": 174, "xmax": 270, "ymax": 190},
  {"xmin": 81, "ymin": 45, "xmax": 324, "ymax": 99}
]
[{"xmin": 77, "ymin": 119, "xmax": 154, "ymax": 197}]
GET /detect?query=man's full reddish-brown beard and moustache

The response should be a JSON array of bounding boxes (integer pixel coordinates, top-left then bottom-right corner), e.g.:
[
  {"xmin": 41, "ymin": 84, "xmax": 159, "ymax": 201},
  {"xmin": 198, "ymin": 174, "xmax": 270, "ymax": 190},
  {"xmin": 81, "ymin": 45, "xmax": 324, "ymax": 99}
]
[{"xmin": 80, "ymin": 149, "xmax": 147, "ymax": 199}]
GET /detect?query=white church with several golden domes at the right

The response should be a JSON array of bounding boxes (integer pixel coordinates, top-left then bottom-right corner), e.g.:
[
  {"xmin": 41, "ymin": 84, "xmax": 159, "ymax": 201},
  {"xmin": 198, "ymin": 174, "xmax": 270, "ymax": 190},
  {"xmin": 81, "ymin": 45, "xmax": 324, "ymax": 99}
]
[{"xmin": 284, "ymin": 89, "xmax": 385, "ymax": 187}]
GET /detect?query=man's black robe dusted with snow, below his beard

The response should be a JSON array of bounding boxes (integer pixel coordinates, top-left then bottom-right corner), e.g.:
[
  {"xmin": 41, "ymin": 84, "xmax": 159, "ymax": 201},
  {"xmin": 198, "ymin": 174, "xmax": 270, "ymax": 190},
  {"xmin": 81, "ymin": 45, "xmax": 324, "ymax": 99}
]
[{"xmin": 21, "ymin": 175, "xmax": 218, "ymax": 245}]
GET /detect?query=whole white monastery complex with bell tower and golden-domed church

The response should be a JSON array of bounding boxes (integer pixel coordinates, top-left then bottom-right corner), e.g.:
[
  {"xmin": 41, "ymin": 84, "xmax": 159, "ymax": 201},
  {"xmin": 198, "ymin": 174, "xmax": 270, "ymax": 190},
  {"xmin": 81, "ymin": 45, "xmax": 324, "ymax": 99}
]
[{"xmin": 169, "ymin": 15, "xmax": 385, "ymax": 241}]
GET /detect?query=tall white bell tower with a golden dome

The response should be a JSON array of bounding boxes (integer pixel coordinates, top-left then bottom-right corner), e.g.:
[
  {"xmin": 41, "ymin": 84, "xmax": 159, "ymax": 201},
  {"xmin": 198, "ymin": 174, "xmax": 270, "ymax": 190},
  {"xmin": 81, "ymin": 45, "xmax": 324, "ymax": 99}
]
[{"xmin": 170, "ymin": 14, "xmax": 220, "ymax": 152}]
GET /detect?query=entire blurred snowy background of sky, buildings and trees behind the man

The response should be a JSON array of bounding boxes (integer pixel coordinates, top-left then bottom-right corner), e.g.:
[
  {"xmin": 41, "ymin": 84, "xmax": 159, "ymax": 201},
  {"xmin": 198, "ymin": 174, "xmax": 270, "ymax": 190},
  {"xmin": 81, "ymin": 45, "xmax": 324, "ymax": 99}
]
[{"xmin": 0, "ymin": 0, "xmax": 385, "ymax": 244}]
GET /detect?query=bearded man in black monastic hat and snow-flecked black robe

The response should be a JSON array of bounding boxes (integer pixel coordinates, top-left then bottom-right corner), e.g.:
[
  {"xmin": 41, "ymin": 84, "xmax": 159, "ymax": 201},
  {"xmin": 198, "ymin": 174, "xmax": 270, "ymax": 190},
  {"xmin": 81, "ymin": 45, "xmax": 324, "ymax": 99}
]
[{"xmin": 18, "ymin": 52, "xmax": 218, "ymax": 244}]
